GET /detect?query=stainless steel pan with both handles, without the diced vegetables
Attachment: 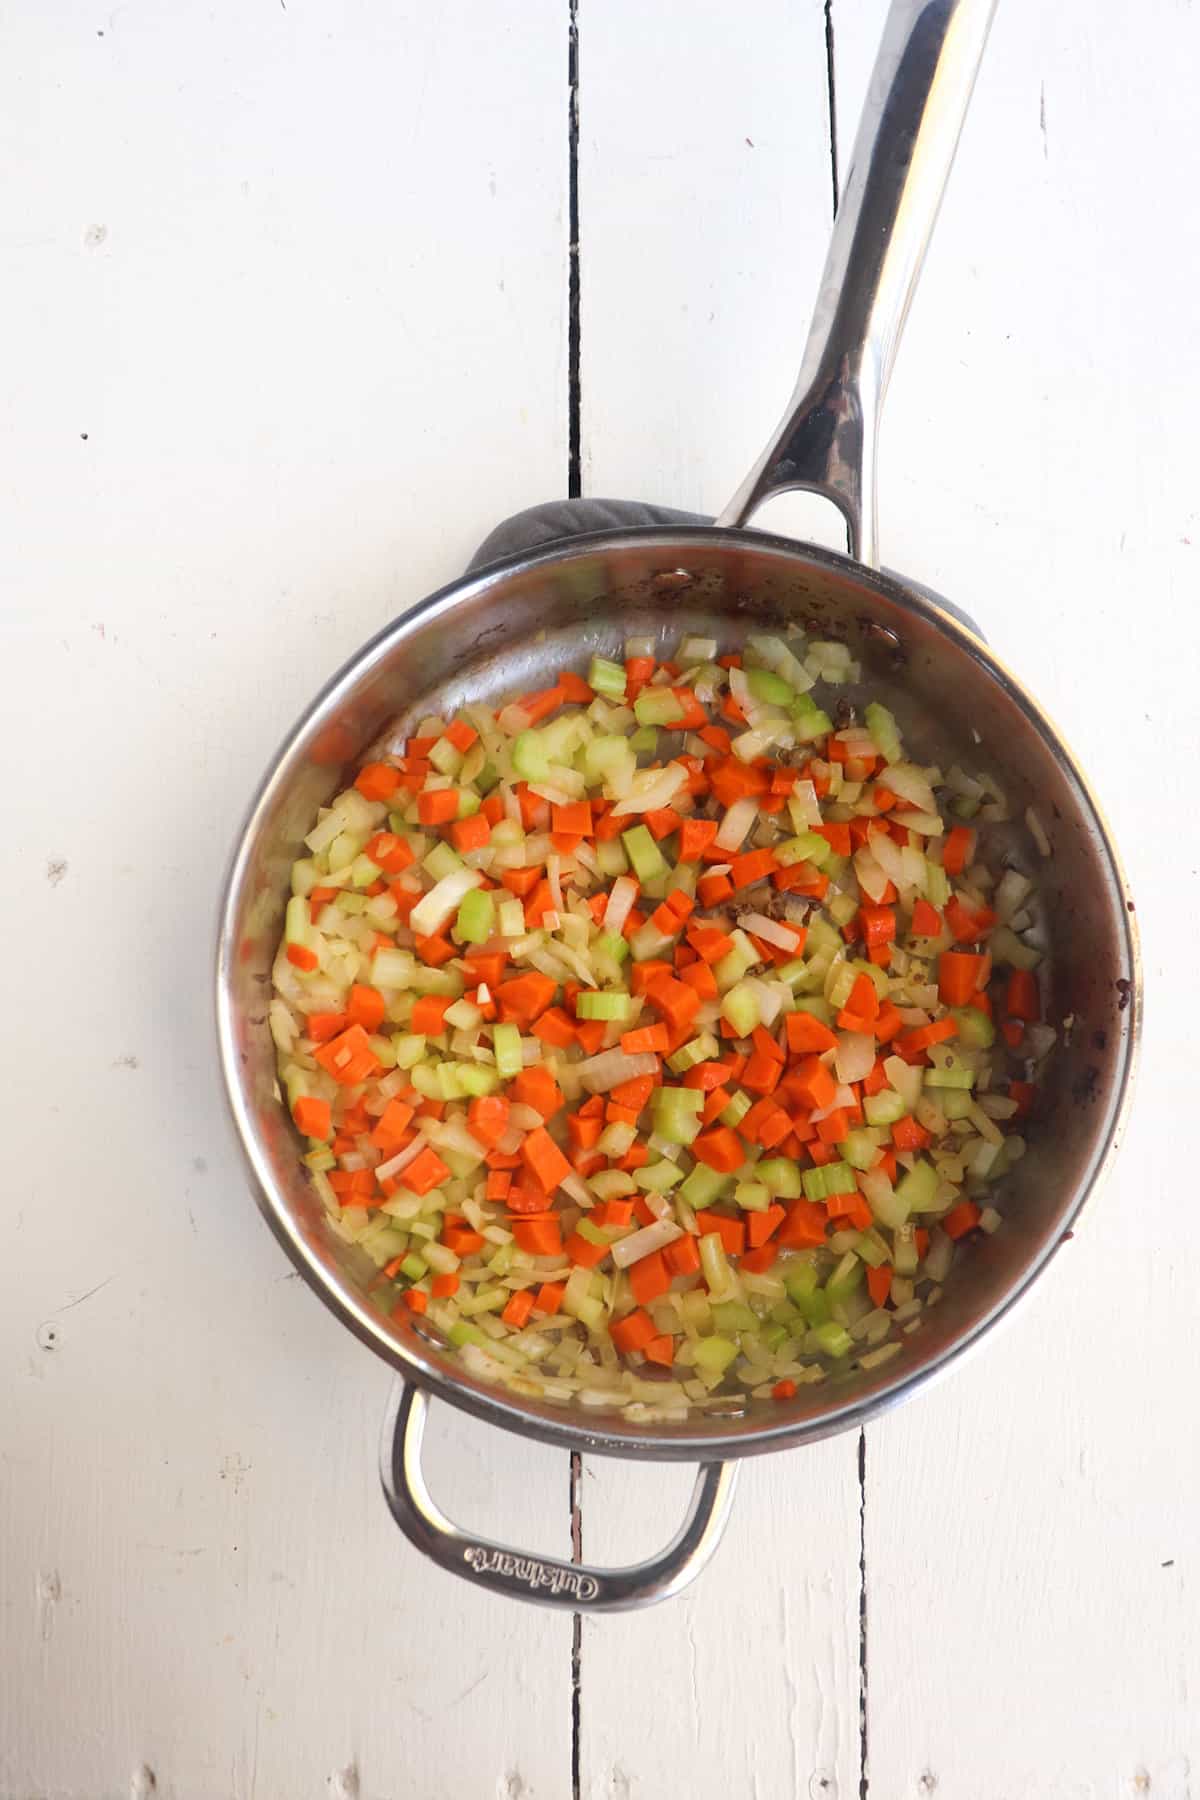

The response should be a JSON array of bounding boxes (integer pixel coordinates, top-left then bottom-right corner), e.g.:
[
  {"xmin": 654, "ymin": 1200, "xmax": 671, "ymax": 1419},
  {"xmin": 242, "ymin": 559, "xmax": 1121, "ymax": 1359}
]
[{"xmin": 218, "ymin": 0, "xmax": 1141, "ymax": 1611}]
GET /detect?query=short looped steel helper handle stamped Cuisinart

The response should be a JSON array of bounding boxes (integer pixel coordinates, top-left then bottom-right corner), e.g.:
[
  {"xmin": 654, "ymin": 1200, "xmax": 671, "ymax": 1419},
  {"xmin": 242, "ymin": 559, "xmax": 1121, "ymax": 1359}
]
[{"xmin": 380, "ymin": 1381, "xmax": 738, "ymax": 1613}]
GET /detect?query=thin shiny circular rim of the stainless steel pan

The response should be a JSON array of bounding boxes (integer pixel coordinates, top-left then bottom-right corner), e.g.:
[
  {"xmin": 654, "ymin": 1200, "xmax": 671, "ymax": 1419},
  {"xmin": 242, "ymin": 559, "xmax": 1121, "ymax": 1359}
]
[{"xmin": 216, "ymin": 526, "xmax": 1142, "ymax": 1462}]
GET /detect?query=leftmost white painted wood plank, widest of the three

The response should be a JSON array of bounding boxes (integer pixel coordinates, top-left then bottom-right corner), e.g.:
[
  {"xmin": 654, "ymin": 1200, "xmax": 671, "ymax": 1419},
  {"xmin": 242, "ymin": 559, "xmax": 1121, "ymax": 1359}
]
[{"xmin": 0, "ymin": 0, "xmax": 570, "ymax": 1800}]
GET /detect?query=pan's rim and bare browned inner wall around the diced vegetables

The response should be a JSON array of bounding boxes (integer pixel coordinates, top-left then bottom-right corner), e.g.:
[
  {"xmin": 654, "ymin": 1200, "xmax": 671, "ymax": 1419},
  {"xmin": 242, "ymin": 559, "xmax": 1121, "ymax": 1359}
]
[{"xmin": 218, "ymin": 529, "xmax": 1135, "ymax": 1456}]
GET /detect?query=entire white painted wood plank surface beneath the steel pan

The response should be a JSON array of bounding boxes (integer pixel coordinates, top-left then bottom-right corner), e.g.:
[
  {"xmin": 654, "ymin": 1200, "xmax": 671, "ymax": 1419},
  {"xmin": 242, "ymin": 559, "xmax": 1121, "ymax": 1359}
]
[{"xmin": 0, "ymin": 0, "xmax": 1200, "ymax": 1800}]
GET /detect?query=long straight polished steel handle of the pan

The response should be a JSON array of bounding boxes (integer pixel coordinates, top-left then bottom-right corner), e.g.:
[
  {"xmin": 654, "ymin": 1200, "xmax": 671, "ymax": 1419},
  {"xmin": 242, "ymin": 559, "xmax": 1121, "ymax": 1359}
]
[{"xmin": 716, "ymin": 0, "xmax": 995, "ymax": 569}]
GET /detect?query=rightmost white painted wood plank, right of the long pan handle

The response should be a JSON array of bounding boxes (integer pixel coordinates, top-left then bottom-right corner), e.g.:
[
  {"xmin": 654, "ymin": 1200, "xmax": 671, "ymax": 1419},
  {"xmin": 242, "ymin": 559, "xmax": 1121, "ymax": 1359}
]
[{"xmin": 835, "ymin": 0, "xmax": 1200, "ymax": 1800}]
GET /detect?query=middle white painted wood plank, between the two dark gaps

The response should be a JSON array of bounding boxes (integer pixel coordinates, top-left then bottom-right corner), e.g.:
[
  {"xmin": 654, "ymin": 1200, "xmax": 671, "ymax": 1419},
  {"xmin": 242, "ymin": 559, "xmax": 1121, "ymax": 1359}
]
[{"xmin": 579, "ymin": 0, "xmax": 858, "ymax": 1800}]
